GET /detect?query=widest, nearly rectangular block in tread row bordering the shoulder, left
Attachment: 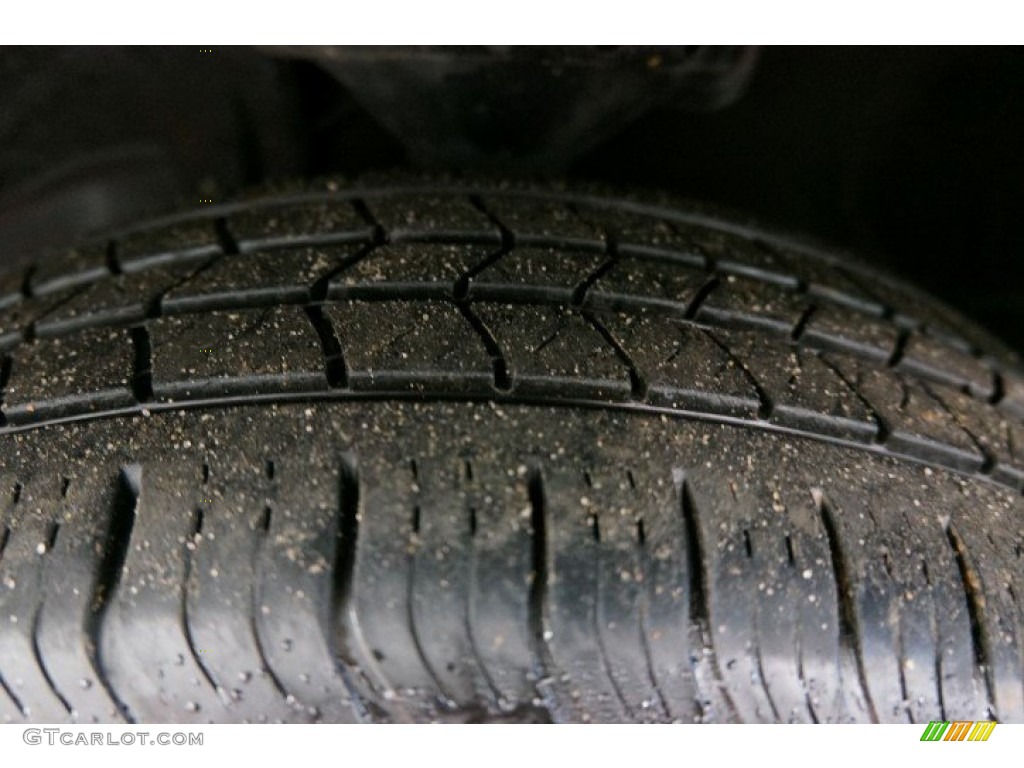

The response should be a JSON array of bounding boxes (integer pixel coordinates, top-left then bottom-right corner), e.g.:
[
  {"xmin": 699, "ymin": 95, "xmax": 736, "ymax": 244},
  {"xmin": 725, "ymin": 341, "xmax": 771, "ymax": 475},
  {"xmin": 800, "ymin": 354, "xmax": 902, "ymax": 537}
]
[{"xmin": 148, "ymin": 306, "xmax": 327, "ymax": 398}]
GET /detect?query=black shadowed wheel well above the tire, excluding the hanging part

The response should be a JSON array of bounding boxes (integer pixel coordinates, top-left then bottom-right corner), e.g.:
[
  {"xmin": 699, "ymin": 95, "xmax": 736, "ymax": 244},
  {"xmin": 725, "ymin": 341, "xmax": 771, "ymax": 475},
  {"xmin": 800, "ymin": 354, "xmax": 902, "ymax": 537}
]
[{"xmin": 0, "ymin": 47, "xmax": 1024, "ymax": 352}]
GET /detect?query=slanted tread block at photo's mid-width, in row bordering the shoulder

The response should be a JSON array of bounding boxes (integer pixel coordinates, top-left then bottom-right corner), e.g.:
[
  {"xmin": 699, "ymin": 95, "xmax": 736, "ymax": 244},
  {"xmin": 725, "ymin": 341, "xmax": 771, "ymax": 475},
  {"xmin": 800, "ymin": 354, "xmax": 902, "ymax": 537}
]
[{"xmin": 473, "ymin": 303, "xmax": 630, "ymax": 399}]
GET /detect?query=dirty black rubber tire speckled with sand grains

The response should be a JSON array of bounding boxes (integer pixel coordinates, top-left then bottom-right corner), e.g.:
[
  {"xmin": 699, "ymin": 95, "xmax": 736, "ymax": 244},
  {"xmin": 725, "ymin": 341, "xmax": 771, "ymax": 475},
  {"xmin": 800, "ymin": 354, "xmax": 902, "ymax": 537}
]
[{"xmin": 0, "ymin": 183, "xmax": 1024, "ymax": 722}]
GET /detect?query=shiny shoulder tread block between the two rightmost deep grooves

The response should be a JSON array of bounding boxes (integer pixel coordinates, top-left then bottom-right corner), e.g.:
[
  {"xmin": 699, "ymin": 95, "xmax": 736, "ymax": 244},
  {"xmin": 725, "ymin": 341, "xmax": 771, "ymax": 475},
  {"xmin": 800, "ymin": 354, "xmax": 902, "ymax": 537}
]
[{"xmin": 826, "ymin": 465, "xmax": 984, "ymax": 722}]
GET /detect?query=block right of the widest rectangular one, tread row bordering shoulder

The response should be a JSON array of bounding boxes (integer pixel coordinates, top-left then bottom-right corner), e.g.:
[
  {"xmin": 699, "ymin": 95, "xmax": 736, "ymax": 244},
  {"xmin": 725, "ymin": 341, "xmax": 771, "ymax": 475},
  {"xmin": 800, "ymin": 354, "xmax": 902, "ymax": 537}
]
[{"xmin": 324, "ymin": 301, "xmax": 494, "ymax": 392}]
